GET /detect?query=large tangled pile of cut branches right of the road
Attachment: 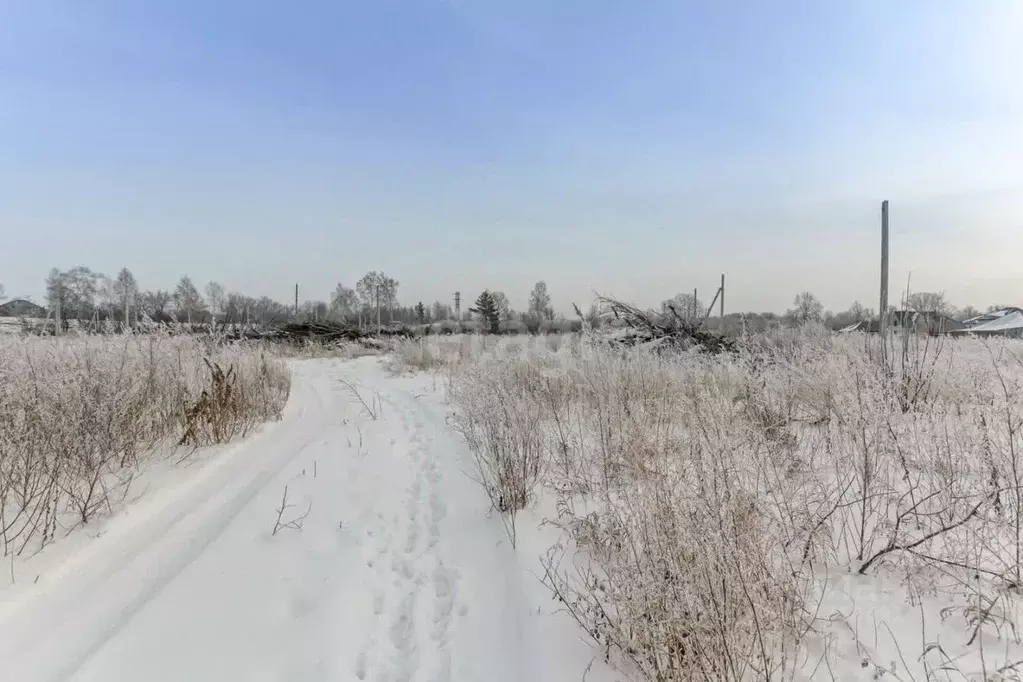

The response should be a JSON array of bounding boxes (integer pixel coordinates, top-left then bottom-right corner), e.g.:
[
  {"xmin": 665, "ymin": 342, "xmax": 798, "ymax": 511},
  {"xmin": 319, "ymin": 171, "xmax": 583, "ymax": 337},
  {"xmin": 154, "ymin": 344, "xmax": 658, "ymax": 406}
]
[{"xmin": 597, "ymin": 297, "xmax": 736, "ymax": 353}]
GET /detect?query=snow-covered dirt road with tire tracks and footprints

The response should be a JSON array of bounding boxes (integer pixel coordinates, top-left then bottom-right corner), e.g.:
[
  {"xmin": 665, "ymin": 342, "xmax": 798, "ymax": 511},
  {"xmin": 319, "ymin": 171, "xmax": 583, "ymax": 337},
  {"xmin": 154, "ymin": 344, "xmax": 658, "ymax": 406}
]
[{"xmin": 0, "ymin": 358, "xmax": 619, "ymax": 682}]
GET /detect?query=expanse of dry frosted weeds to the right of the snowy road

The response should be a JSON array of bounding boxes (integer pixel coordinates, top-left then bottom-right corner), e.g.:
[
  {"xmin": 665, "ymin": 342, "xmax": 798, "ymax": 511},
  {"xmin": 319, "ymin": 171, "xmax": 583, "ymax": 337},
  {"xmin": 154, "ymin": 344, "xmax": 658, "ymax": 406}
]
[{"xmin": 445, "ymin": 327, "xmax": 1023, "ymax": 681}]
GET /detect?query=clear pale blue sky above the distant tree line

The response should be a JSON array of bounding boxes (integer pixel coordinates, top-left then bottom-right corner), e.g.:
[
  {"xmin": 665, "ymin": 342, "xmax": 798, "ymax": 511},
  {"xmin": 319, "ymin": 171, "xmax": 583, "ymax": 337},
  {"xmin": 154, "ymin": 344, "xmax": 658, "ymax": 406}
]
[{"xmin": 0, "ymin": 0, "xmax": 1023, "ymax": 312}]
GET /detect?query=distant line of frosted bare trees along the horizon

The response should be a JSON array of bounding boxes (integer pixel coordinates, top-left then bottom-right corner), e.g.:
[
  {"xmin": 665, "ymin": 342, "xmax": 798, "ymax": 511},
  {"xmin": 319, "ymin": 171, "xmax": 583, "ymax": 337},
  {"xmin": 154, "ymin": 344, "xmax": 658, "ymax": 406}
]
[{"xmin": 0, "ymin": 266, "xmax": 1006, "ymax": 329}]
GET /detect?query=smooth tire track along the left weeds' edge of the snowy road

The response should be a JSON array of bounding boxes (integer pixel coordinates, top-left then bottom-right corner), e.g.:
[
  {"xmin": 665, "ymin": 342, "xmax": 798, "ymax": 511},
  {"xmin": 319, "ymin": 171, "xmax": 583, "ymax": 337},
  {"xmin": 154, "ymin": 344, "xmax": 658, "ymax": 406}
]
[{"xmin": 0, "ymin": 370, "xmax": 331, "ymax": 682}]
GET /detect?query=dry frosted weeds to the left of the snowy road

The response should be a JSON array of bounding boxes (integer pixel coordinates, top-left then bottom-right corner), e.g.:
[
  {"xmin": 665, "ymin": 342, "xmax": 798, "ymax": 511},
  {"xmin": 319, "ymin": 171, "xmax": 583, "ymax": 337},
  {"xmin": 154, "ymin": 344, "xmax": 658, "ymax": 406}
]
[{"xmin": 0, "ymin": 336, "xmax": 291, "ymax": 555}]
